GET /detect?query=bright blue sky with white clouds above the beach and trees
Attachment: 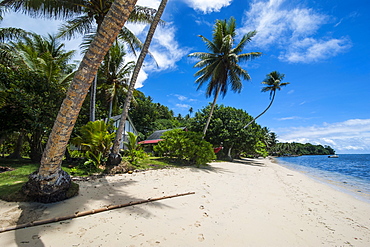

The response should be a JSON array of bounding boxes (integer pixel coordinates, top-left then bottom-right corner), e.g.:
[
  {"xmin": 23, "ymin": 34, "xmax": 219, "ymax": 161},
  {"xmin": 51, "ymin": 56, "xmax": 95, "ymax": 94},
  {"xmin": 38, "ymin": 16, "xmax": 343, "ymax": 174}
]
[{"xmin": 1, "ymin": 0, "xmax": 370, "ymax": 153}]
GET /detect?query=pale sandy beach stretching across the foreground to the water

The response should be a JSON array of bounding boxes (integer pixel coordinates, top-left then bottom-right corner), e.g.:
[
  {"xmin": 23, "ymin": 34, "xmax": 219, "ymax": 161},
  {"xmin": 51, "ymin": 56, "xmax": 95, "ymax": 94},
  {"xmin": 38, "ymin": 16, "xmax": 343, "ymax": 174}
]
[{"xmin": 0, "ymin": 158, "xmax": 370, "ymax": 247}]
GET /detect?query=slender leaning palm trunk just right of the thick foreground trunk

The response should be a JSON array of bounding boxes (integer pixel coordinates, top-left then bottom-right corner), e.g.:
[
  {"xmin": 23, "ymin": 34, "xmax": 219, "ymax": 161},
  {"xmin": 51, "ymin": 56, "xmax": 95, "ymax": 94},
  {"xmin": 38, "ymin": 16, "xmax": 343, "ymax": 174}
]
[{"xmin": 109, "ymin": 0, "xmax": 167, "ymax": 157}]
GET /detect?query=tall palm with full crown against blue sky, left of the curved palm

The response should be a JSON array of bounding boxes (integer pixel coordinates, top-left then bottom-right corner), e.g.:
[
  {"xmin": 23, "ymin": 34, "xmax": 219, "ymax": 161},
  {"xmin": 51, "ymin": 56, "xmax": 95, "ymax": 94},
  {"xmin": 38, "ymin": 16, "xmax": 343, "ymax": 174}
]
[{"xmin": 189, "ymin": 17, "xmax": 261, "ymax": 137}]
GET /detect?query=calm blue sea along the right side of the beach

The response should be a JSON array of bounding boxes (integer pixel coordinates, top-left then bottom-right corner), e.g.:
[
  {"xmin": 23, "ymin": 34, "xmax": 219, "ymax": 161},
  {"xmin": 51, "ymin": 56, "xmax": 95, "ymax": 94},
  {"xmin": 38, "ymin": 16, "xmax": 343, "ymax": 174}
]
[{"xmin": 277, "ymin": 154, "xmax": 370, "ymax": 202}]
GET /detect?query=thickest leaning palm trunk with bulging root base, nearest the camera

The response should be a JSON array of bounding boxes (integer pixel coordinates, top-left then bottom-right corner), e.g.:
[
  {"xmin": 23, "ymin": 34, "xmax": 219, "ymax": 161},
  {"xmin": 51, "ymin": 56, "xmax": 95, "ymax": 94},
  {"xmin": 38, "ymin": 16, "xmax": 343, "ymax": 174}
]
[{"xmin": 23, "ymin": 0, "xmax": 137, "ymax": 202}]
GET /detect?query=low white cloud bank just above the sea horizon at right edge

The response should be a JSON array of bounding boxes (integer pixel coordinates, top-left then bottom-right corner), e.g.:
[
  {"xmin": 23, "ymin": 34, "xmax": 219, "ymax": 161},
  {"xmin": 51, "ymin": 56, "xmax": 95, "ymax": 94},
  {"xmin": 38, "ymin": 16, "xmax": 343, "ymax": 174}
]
[{"xmin": 273, "ymin": 119, "xmax": 370, "ymax": 153}]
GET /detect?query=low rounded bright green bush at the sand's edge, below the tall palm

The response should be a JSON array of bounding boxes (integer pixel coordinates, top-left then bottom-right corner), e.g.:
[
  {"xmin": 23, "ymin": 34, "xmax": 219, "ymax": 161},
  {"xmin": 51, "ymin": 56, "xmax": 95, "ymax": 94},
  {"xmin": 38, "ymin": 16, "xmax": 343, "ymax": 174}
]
[{"xmin": 154, "ymin": 129, "xmax": 216, "ymax": 165}]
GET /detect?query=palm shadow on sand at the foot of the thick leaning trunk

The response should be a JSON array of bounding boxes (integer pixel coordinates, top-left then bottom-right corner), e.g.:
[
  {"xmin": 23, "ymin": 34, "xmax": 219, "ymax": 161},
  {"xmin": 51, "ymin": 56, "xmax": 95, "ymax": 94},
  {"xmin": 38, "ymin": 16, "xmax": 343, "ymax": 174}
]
[{"xmin": 14, "ymin": 177, "xmax": 172, "ymax": 246}]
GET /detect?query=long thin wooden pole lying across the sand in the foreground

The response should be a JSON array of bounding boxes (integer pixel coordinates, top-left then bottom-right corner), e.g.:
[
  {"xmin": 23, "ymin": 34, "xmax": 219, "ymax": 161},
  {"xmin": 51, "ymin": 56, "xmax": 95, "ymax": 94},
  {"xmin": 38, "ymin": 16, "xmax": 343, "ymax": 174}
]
[{"xmin": 0, "ymin": 192, "xmax": 195, "ymax": 233}]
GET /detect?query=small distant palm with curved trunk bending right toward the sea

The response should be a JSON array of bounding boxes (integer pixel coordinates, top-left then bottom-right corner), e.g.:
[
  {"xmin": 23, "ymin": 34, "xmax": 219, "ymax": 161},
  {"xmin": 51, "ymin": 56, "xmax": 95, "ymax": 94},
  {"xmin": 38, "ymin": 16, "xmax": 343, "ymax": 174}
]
[{"xmin": 244, "ymin": 71, "xmax": 290, "ymax": 128}]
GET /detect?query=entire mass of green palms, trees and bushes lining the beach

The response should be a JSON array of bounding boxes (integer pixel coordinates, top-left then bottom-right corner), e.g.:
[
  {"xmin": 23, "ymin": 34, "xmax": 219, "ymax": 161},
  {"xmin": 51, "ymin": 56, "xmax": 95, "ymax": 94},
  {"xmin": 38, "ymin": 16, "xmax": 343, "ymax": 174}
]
[{"xmin": 0, "ymin": 0, "xmax": 334, "ymax": 205}]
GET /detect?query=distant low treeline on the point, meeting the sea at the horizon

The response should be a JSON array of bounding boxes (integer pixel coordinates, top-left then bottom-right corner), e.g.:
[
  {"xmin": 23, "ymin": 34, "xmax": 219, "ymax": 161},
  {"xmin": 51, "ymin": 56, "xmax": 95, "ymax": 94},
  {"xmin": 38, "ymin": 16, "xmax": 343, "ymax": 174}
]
[{"xmin": 270, "ymin": 142, "xmax": 335, "ymax": 156}]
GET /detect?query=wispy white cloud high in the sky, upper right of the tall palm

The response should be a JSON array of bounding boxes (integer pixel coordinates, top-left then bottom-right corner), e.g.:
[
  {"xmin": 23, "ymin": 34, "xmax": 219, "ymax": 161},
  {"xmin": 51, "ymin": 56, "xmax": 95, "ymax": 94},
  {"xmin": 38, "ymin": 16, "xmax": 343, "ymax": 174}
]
[{"xmin": 240, "ymin": 0, "xmax": 351, "ymax": 63}]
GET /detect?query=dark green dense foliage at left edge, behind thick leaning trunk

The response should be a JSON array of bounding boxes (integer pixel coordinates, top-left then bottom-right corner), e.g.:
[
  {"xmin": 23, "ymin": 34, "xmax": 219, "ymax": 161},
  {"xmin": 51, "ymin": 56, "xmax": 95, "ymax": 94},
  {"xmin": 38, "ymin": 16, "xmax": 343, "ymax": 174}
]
[{"xmin": 0, "ymin": 65, "xmax": 67, "ymax": 161}]
